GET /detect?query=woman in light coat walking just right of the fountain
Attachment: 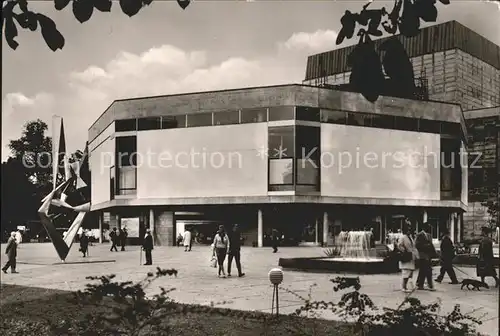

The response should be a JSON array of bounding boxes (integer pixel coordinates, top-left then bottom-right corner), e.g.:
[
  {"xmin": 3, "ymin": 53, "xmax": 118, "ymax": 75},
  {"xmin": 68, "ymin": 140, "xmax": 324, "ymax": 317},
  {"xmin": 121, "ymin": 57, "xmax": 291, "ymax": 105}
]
[{"xmin": 397, "ymin": 224, "xmax": 418, "ymax": 293}]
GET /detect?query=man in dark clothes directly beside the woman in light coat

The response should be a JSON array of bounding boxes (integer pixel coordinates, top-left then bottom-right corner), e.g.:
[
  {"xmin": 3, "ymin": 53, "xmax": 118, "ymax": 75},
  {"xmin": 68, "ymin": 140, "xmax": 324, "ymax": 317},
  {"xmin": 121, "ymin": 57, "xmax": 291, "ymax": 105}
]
[{"xmin": 415, "ymin": 223, "xmax": 436, "ymax": 291}]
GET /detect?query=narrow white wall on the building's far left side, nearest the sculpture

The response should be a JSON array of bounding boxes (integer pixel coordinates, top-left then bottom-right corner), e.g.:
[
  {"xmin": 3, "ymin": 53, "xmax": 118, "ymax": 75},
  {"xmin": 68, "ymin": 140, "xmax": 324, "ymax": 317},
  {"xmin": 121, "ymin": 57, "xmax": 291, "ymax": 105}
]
[{"xmin": 89, "ymin": 128, "xmax": 115, "ymax": 205}]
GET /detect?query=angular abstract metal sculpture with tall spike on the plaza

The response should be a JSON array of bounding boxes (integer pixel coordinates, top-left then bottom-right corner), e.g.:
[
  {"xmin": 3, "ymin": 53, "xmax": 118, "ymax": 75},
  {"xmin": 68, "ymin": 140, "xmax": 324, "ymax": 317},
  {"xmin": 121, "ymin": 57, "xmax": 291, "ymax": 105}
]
[{"xmin": 38, "ymin": 117, "xmax": 90, "ymax": 262}]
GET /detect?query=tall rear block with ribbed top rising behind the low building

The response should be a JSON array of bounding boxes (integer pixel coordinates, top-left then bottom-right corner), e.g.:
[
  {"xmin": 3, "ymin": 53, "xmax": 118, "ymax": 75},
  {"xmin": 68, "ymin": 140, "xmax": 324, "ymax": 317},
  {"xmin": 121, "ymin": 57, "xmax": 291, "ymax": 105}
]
[{"xmin": 303, "ymin": 21, "xmax": 500, "ymax": 111}]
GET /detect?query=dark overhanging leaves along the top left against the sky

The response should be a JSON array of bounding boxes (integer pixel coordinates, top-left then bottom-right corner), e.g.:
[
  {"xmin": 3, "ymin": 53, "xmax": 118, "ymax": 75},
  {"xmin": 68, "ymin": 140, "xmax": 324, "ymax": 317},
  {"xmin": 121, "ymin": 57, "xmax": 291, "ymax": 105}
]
[{"xmin": 2, "ymin": 0, "xmax": 191, "ymax": 51}]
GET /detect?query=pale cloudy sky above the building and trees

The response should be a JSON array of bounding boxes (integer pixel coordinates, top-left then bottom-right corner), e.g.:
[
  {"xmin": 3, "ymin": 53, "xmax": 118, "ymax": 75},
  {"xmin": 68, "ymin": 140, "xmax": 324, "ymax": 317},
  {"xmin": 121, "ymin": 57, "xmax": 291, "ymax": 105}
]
[{"xmin": 2, "ymin": 0, "xmax": 500, "ymax": 161}]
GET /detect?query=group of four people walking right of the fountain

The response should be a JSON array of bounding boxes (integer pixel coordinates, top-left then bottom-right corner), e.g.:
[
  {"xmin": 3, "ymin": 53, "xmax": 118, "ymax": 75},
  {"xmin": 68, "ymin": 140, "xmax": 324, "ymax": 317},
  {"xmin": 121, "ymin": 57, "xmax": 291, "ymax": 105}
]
[{"xmin": 395, "ymin": 220, "xmax": 499, "ymax": 292}]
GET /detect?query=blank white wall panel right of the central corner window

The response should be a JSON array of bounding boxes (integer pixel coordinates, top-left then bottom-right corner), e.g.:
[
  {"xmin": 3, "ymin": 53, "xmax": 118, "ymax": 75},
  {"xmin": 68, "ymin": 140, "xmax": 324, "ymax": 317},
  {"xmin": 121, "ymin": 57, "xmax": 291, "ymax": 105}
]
[{"xmin": 321, "ymin": 124, "xmax": 440, "ymax": 200}]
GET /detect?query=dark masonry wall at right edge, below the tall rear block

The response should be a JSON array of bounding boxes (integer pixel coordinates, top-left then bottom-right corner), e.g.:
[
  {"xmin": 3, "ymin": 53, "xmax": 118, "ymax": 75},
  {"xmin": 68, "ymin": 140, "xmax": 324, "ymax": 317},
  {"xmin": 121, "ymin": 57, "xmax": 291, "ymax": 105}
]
[{"xmin": 464, "ymin": 106, "xmax": 500, "ymax": 238}]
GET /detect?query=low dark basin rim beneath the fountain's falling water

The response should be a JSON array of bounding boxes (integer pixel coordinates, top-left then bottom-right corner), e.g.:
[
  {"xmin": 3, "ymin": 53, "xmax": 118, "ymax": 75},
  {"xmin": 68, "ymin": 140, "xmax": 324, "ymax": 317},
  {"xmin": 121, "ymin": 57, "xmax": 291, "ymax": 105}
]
[{"xmin": 279, "ymin": 257, "xmax": 399, "ymax": 274}]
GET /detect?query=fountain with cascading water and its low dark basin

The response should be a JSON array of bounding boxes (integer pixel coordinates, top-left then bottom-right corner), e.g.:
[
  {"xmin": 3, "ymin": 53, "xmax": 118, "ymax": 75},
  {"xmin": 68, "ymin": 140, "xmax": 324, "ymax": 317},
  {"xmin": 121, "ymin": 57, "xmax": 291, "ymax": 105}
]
[{"xmin": 279, "ymin": 231, "xmax": 398, "ymax": 274}]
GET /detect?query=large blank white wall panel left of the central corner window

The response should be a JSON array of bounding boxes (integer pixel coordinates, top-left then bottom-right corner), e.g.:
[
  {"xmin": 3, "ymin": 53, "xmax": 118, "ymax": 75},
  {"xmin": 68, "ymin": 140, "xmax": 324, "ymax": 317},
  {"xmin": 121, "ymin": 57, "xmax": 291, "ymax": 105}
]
[{"xmin": 137, "ymin": 123, "xmax": 267, "ymax": 198}]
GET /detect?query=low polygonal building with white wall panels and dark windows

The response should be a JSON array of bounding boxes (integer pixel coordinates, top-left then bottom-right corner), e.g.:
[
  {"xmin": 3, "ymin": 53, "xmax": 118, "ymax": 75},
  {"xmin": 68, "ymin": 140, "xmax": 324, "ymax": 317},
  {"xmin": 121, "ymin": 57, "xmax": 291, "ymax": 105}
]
[{"xmin": 89, "ymin": 85, "xmax": 467, "ymax": 246}]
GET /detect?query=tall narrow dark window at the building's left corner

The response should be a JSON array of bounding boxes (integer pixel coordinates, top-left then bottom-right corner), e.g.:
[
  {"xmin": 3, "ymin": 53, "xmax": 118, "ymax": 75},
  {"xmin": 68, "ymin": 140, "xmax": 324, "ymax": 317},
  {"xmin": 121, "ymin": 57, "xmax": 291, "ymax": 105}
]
[{"xmin": 115, "ymin": 136, "xmax": 137, "ymax": 195}]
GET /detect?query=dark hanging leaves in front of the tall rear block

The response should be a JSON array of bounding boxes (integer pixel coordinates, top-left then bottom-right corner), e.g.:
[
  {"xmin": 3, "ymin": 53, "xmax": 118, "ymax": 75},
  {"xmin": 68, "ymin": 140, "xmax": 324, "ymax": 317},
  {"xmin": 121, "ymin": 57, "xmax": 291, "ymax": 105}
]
[{"xmin": 336, "ymin": 0, "xmax": 450, "ymax": 102}]
